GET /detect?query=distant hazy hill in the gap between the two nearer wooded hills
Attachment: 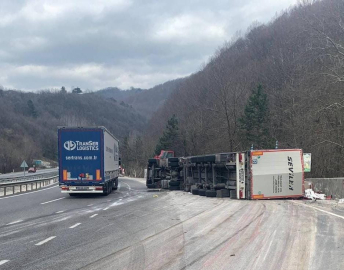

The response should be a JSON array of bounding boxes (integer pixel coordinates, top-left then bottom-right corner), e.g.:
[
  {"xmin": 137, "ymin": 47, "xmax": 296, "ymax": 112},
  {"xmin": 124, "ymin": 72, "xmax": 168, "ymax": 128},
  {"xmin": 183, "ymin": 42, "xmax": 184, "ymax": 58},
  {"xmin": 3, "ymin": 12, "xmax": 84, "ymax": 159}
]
[{"xmin": 95, "ymin": 79, "xmax": 184, "ymax": 119}]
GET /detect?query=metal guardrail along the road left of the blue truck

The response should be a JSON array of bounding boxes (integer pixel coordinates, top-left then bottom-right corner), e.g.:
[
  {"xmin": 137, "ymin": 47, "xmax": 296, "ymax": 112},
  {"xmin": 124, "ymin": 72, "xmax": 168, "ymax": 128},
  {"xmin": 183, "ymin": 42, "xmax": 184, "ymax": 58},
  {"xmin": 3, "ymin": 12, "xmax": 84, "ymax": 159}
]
[{"xmin": 0, "ymin": 175, "xmax": 58, "ymax": 197}]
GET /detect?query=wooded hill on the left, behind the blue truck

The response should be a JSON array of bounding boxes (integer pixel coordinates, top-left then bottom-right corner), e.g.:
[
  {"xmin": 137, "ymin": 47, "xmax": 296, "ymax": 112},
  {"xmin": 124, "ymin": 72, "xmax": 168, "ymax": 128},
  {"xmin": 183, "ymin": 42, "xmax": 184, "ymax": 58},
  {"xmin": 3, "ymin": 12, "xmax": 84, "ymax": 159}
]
[{"xmin": 0, "ymin": 90, "xmax": 146, "ymax": 172}]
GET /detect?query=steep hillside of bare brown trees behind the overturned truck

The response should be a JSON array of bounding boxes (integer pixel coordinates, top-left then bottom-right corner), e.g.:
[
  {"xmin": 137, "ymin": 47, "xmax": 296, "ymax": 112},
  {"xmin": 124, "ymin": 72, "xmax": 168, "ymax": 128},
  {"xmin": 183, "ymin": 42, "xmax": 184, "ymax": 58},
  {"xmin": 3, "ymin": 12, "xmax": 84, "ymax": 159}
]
[{"xmin": 147, "ymin": 0, "xmax": 344, "ymax": 177}]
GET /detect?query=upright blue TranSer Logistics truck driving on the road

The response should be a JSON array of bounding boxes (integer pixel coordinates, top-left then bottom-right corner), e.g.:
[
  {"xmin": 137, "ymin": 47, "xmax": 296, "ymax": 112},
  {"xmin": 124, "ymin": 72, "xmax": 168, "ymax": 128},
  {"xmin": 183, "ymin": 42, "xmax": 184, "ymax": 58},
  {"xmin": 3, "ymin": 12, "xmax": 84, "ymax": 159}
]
[{"xmin": 58, "ymin": 127, "xmax": 120, "ymax": 196}]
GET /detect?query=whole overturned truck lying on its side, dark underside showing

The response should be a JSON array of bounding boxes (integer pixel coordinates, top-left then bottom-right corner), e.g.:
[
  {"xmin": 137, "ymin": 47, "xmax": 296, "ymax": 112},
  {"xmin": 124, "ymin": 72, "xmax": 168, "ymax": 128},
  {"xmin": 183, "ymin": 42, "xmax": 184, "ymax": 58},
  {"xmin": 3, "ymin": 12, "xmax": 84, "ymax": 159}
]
[{"xmin": 146, "ymin": 149, "xmax": 304, "ymax": 199}]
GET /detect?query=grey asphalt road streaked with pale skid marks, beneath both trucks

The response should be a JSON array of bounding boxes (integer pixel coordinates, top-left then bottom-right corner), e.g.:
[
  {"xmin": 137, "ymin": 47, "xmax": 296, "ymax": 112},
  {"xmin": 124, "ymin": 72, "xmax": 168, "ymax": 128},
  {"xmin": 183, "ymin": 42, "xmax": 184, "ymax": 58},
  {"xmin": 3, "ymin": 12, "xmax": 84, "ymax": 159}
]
[{"xmin": 0, "ymin": 178, "xmax": 344, "ymax": 270}]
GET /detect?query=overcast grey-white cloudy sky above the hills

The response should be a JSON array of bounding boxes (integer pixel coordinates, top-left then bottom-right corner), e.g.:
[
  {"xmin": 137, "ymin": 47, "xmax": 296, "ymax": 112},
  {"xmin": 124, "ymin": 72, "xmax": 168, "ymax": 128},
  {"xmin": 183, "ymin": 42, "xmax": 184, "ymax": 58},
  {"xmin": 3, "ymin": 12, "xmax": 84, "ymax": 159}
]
[{"xmin": 0, "ymin": 0, "xmax": 296, "ymax": 90}]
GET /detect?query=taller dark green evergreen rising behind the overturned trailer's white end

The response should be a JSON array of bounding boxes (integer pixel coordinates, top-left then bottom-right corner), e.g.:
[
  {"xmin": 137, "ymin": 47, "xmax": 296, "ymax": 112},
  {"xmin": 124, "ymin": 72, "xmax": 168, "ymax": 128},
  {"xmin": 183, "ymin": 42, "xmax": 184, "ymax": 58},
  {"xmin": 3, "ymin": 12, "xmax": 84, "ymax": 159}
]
[{"xmin": 239, "ymin": 85, "xmax": 273, "ymax": 149}]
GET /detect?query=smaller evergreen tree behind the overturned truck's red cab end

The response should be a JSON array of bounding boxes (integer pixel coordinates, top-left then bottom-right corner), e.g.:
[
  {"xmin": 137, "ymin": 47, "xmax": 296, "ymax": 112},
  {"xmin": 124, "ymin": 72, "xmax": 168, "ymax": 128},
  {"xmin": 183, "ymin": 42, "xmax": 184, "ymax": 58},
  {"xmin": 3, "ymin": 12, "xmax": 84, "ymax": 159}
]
[{"xmin": 155, "ymin": 115, "xmax": 180, "ymax": 155}]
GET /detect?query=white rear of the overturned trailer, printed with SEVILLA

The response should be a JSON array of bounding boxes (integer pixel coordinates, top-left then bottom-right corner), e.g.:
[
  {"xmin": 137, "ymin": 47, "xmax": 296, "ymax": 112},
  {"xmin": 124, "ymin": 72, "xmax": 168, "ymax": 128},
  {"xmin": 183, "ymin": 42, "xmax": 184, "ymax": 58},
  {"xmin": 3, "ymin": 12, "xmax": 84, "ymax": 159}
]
[{"xmin": 250, "ymin": 149, "xmax": 304, "ymax": 199}]
